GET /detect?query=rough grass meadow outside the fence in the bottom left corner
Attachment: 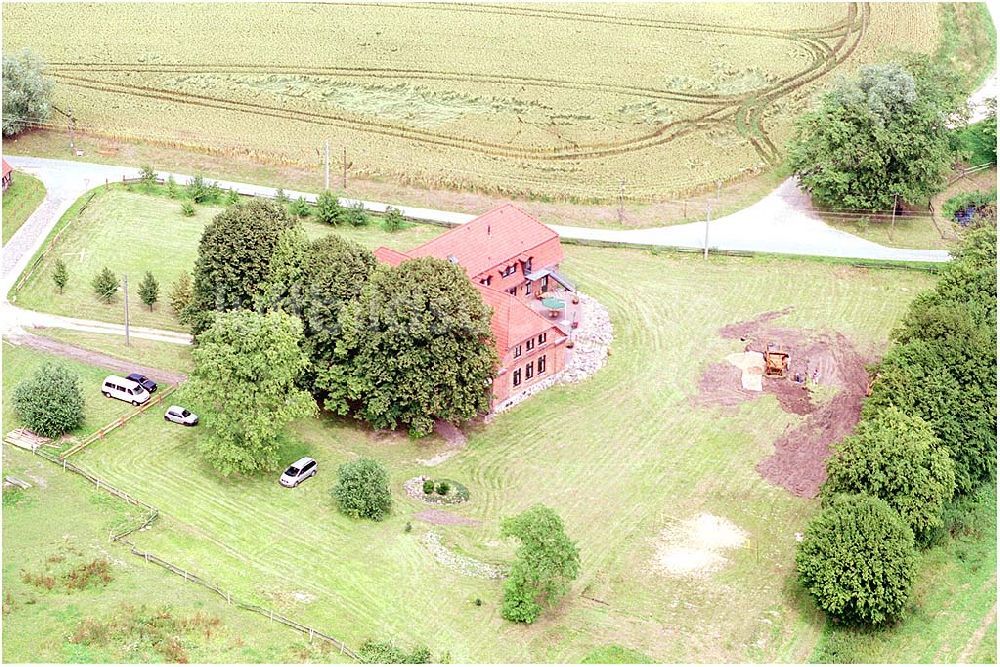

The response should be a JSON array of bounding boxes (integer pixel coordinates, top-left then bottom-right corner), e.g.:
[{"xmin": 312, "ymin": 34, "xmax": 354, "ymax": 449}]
[{"xmin": 3, "ymin": 440, "xmax": 352, "ymax": 663}]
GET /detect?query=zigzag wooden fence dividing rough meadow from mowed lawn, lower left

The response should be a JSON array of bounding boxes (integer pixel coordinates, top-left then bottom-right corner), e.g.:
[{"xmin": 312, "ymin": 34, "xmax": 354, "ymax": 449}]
[{"xmin": 26, "ymin": 444, "xmax": 361, "ymax": 662}]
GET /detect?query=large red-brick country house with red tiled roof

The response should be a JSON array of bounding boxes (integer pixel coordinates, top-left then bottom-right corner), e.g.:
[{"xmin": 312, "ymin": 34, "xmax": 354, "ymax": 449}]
[{"xmin": 375, "ymin": 204, "xmax": 577, "ymax": 406}]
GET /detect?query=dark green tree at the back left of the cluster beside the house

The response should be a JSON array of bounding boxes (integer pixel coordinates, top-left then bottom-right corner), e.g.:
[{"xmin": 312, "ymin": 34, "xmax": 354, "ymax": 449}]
[{"xmin": 184, "ymin": 199, "xmax": 292, "ymax": 334}]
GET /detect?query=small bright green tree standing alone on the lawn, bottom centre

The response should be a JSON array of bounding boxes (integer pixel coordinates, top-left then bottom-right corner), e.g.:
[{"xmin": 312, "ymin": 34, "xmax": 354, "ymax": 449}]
[{"xmin": 500, "ymin": 505, "xmax": 580, "ymax": 623}]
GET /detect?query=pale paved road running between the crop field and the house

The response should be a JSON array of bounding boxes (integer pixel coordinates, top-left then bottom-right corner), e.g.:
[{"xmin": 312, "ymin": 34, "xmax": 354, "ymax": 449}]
[{"xmin": 4, "ymin": 155, "xmax": 949, "ymax": 268}]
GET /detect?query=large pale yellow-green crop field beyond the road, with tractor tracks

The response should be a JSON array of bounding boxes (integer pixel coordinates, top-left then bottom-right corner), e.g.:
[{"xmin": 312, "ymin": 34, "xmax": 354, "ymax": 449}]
[{"xmin": 3, "ymin": 3, "xmax": 952, "ymax": 202}]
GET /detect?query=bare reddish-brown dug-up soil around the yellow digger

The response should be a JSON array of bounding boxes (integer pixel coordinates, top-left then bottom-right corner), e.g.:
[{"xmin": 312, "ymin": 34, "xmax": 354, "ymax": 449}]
[{"xmin": 695, "ymin": 308, "xmax": 872, "ymax": 498}]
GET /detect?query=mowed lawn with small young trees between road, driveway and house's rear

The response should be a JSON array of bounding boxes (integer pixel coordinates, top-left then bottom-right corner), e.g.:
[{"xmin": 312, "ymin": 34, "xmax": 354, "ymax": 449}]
[{"xmin": 15, "ymin": 186, "xmax": 442, "ymax": 331}]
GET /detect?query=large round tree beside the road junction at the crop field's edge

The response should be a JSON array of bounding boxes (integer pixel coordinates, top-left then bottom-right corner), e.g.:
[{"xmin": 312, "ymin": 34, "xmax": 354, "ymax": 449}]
[{"xmin": 789, "ymin": 60, "xmax": 960, "ymax": 210}]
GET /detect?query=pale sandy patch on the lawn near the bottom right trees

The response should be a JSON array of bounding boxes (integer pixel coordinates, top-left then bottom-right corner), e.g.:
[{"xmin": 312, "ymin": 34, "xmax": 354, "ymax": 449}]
[{"xmin": 653, "ymin": 513, "xmax": 747, "ymax": 577}]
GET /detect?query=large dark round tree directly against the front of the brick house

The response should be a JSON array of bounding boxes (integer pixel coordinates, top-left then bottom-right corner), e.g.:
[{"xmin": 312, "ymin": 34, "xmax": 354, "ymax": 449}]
[{"xmin": 317, "ymin": 257, "xmax": 497, "ymax": 436}]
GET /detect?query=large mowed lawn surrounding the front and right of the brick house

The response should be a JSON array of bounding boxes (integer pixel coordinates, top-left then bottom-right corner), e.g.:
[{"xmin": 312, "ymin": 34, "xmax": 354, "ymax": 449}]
[{"xmin": 77, "ymin": 244, "xmax": 933, "ymax": 662}]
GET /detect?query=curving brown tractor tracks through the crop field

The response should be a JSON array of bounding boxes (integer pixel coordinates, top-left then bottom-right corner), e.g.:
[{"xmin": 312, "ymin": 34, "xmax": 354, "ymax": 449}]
[{"xmin": 50, "ymin": 3, "xmax": 870, "ymax": 170}]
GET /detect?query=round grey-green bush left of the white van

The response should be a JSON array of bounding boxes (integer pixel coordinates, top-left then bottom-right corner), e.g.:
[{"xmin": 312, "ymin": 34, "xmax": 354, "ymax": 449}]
[{"xmin": 14, "ymin": 363, "xmax": 84, "ymax": 438}]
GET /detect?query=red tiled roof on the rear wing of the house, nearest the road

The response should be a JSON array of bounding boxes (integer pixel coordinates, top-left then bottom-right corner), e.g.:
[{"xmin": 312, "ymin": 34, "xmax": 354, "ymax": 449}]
[{"xmin": 407, "ymin": 204, "xmax": 563, "ymax": 278}]
